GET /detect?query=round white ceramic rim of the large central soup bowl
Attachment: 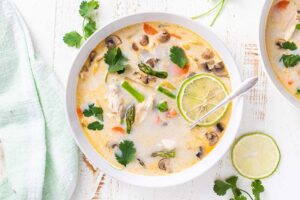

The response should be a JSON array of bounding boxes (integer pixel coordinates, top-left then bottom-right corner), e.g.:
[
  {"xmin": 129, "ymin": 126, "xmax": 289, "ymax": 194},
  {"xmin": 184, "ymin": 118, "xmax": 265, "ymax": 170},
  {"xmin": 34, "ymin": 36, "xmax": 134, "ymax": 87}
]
[{"xmin": 66, "ymin": 12, "xmax": 243, "ymax": 187}]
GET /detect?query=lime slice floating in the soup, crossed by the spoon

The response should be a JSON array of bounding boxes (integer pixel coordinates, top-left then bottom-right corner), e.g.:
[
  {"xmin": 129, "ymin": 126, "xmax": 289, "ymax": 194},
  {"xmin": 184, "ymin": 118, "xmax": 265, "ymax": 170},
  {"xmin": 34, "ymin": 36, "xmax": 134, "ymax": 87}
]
[{"xmin": 177, "ymin": 74, "xmax": 228, "ymax": 126}]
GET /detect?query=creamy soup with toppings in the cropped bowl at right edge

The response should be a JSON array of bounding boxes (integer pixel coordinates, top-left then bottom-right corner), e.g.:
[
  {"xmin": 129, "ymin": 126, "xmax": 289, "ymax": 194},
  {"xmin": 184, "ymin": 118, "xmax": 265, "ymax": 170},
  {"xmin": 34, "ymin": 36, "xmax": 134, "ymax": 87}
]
[{"xmin": 266, "ymin": 0, "xmax": 300, "ymax": 99}]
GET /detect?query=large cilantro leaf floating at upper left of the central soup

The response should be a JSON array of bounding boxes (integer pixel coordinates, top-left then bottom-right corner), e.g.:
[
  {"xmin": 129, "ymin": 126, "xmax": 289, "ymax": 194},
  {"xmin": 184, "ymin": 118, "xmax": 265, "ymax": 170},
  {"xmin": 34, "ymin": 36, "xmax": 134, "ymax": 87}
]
[{"xmin": 104, "ymin": 47, "xmax": 128, "ymax": 73}]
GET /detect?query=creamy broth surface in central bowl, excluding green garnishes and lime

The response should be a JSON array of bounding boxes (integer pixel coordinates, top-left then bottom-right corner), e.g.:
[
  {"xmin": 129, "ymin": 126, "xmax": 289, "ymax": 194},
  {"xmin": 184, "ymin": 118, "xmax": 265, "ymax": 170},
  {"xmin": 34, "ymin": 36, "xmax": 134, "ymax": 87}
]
[{"xmin": 77, "ymin": 22, "xmax": 231, "ymax": 175}]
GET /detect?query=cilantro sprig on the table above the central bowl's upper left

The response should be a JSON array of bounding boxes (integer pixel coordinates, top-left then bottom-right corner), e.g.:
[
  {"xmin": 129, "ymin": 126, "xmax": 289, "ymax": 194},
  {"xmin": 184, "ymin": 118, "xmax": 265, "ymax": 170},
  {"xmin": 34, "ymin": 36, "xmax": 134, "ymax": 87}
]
[{"xmin": 63, "ymin": 0, "xmax": 99, "ymax": 48}]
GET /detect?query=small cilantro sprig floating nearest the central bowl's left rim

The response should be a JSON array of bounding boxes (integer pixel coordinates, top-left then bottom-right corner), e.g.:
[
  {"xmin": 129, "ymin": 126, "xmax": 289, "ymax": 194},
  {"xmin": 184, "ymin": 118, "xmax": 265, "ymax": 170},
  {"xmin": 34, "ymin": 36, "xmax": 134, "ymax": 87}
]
[{"xmin": 83, "ymin": 104, "xmax": 104, "ymax": 131}]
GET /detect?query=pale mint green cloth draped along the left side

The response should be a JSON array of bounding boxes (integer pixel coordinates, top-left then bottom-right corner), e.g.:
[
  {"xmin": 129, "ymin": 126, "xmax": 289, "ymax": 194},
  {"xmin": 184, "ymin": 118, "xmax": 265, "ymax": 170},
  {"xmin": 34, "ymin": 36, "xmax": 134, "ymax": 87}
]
[{"xmin": 0, "ymin": 0, "xmax": 79, "ymax": 200}]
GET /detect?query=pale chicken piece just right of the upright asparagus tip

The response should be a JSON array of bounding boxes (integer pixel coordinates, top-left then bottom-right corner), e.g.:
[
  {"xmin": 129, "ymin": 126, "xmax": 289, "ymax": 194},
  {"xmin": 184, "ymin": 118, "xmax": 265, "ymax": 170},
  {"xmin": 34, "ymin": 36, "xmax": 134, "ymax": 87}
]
[{"xmin": 135, "ymin": 96, "xmax": 154, "ymax": 124}]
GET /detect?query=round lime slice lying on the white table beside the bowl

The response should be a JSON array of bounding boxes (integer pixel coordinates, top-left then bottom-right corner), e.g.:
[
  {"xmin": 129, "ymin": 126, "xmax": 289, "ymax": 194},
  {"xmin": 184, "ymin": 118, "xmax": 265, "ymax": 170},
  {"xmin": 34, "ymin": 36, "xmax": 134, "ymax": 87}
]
[{"xmin": 231, "ymin": 132, "xmax": 280, "ymax": 179}]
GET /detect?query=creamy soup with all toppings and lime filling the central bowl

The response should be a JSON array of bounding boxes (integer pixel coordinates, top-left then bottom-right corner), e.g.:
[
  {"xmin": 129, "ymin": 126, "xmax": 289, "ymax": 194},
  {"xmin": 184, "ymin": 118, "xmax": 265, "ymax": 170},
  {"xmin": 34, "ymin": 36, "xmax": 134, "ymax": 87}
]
[{"xmin": 76, "ymin": 22, "xmax": 231, "ymax": 175}]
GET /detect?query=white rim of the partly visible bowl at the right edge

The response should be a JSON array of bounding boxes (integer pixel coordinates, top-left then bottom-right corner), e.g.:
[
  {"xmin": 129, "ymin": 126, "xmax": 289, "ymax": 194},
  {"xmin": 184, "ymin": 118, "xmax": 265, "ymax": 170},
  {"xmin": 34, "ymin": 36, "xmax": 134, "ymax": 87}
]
[{"xmin": 258, "ymin": 0, "xmax": 300, "ymax": 109}]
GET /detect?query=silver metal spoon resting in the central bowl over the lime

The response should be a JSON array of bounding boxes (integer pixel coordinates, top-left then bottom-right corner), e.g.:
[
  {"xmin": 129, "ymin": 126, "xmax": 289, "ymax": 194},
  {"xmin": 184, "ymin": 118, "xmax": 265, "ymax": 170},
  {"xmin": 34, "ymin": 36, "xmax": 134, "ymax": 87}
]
[{"xmin": 190, "ymin": 76, "xmax": 258, "ymax": 129}]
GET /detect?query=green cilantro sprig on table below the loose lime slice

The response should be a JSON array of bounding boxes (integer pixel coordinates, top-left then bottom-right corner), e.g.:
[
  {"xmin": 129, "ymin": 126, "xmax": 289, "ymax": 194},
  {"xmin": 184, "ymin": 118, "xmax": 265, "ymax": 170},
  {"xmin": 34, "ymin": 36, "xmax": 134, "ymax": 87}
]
[{"xmin": 213, "ymin": 176, "xmax": 265, "ymax": 200}]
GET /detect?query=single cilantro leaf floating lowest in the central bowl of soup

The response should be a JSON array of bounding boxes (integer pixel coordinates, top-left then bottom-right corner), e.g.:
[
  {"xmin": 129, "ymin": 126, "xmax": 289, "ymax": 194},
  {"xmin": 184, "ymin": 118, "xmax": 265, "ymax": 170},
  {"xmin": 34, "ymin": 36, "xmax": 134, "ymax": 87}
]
[{"xmin": 115, "ymin": 140, "xmax": 136, "ymax": 167}]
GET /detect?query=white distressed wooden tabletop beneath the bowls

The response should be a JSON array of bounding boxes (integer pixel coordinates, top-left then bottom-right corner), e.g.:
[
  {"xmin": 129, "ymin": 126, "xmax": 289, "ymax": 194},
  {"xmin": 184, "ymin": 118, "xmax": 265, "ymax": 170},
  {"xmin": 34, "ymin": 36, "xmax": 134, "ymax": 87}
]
[{"xmin": 10, "ymin": 0, "xmax": 300, "ymax": 200}]
